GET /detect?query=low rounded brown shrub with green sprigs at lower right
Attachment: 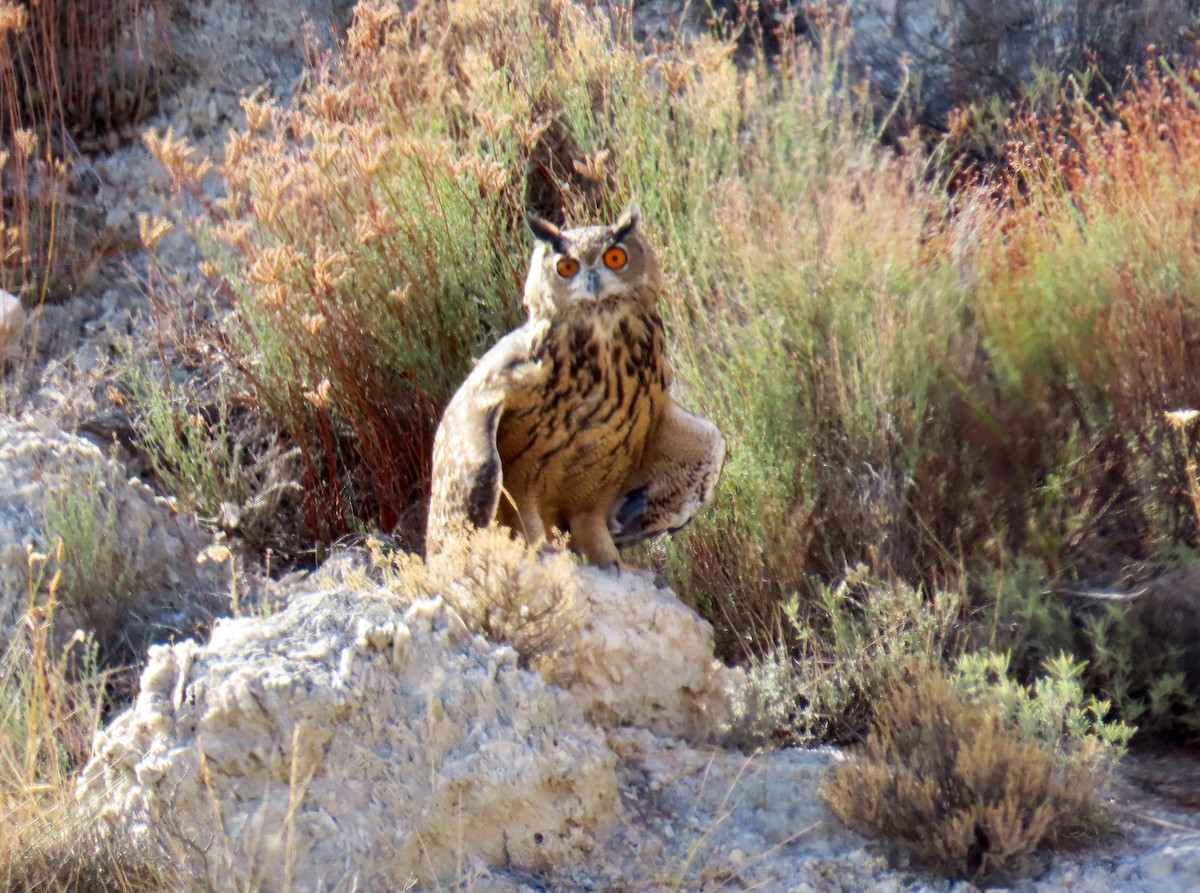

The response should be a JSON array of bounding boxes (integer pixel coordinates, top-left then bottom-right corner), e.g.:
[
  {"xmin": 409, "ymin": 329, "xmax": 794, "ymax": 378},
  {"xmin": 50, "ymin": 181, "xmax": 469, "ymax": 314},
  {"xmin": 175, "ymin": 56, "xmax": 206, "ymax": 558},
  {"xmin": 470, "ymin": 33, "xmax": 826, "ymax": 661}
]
[{"xmin": 822, "ymin": 654, "xmax": 1133, "ymax": 880}]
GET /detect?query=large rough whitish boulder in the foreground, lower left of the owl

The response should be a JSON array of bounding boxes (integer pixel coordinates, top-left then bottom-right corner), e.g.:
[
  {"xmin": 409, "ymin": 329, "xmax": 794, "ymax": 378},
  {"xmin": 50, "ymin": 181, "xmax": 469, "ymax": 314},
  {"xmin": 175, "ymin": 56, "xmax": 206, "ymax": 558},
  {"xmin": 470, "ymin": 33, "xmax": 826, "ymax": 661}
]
[{"xmin": 79, "ymin": 587, "xmax": 622, "ymax": 893}]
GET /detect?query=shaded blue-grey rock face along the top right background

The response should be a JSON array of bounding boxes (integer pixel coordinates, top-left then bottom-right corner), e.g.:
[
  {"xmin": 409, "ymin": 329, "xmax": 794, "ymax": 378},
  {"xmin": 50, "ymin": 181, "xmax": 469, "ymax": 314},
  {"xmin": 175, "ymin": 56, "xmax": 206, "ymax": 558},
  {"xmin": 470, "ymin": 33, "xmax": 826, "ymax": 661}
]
[{"xmin": 648, "ymin": 0, "xmax": 1200, "ymax": 127}]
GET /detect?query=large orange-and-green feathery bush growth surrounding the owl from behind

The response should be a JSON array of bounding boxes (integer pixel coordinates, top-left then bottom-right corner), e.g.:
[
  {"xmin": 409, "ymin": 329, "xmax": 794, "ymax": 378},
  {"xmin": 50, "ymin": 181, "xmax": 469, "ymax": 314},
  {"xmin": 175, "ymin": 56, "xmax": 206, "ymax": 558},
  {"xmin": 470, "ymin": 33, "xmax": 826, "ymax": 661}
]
[{"xmin": 142, "ymin": 0, "xmax": 977, "ymax": 643}]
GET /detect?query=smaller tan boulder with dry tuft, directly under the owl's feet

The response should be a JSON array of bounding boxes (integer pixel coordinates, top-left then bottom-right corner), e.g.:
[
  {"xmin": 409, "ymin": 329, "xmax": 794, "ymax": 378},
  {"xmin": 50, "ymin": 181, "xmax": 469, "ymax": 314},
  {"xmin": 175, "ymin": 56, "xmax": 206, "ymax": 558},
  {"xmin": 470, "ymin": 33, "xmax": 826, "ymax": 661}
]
[{"xmin": 388, "ymin": 528, "xmax": 743, "ymax": 743}]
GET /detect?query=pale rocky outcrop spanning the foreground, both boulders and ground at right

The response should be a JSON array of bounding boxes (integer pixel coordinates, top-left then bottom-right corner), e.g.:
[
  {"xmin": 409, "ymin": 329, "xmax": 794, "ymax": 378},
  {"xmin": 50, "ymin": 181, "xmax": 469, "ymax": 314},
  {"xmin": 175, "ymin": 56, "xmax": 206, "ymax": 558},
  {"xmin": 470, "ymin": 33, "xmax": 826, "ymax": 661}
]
[{"xmin": 70, "ymin": 544, "xmax": 1200, "ymax": 893}]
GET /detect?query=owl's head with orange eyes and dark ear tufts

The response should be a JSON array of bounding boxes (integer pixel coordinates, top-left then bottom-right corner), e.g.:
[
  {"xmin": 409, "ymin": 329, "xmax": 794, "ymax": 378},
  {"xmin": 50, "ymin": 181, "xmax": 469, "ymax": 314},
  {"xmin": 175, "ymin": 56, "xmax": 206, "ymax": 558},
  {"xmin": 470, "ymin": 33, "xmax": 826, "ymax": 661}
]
[{"xmin": 524, "ymin": 206, "xmax": 662, "ymax": 319}]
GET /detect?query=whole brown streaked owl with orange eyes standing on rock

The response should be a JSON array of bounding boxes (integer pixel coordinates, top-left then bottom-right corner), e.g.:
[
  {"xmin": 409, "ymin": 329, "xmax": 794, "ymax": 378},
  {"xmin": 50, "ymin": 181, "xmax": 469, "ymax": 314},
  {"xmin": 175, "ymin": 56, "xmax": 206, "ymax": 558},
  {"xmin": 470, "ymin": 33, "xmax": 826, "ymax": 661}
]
[{"xmin": 426, "ymin": 208, "xmax": 725, "ymax": 568}]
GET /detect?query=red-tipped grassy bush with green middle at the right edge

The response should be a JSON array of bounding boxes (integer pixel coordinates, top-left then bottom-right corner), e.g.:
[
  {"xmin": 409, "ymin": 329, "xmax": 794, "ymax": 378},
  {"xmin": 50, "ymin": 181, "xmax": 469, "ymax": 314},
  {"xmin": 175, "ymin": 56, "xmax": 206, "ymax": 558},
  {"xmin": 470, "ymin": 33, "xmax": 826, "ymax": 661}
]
[{"xmin": 980, "ymin": 60, "xmax": 1200, "ymax": 559}]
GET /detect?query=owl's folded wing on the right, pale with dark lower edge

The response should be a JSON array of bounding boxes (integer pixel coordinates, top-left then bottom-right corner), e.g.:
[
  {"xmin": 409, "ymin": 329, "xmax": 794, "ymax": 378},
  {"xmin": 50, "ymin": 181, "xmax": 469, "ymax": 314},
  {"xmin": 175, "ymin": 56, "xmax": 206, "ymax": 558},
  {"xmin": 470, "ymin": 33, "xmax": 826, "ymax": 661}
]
[{"xmin": 608, "ymin": 401, "xmax": 725, "ymax": 549}]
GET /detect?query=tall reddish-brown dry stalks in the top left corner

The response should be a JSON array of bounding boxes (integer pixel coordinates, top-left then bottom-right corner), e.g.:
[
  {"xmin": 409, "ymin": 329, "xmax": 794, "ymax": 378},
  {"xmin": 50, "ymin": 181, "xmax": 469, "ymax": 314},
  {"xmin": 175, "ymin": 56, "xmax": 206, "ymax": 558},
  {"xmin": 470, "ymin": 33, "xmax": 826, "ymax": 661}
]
[{"xmin": 0, "ymin": 0, "xmax": 175, "ymax": 301}]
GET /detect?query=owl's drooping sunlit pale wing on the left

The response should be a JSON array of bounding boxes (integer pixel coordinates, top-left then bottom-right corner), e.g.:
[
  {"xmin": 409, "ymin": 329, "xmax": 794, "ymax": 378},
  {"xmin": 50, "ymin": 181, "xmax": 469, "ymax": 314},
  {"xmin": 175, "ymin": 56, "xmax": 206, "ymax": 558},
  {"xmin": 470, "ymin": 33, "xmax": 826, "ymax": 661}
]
[{"xmin": 425, "ymin": 325, "xmax": 540, "ymax": 555}]
